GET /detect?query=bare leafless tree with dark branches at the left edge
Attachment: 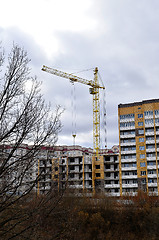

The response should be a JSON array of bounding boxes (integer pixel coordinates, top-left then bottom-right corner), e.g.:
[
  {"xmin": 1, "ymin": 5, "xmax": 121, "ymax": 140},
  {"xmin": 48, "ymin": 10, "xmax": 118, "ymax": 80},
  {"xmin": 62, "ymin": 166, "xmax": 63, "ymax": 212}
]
[{"xmin": 0, "ymin": 44, "xmax": 61, "ymax": 239}]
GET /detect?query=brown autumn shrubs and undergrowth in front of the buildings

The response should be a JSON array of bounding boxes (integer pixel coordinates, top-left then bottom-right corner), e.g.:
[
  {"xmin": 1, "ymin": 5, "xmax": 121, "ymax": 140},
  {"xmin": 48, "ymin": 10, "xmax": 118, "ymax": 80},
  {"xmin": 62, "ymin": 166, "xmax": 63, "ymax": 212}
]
[{"xmin": 0, "ymin": 193, "xmax": 159, "ymax": 240}]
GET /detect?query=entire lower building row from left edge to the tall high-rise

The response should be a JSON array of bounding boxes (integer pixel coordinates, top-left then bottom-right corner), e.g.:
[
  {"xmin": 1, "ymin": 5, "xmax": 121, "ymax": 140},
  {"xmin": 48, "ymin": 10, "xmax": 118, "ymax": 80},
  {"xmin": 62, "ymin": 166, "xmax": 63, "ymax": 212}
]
[{"xmin": 0, "ymin": 144, "xmax": 120, "ymax": 196}]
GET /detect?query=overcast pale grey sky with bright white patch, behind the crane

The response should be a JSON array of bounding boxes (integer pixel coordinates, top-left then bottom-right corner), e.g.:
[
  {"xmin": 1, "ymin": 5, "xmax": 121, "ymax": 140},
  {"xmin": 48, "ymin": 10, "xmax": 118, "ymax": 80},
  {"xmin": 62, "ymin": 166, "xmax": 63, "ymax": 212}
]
[{"xmin": 0, "ymin": 0, "xmax": 159, "ymax": 147}]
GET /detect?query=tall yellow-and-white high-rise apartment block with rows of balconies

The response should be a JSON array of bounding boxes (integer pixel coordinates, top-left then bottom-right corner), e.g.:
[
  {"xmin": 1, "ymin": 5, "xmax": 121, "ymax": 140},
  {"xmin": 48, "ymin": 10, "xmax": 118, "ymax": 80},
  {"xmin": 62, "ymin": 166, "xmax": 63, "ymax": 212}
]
[{"xmin": 118, "ymin": 99, "xmax": 159, "ymax": 195}]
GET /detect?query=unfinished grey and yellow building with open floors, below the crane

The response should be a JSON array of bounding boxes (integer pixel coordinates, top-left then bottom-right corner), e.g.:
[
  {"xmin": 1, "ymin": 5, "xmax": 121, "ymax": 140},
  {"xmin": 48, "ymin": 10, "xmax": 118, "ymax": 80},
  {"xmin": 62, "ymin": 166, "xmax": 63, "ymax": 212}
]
[{"xmin": 37, "ymin": 146, "xmax": 120, "ymax": 196}]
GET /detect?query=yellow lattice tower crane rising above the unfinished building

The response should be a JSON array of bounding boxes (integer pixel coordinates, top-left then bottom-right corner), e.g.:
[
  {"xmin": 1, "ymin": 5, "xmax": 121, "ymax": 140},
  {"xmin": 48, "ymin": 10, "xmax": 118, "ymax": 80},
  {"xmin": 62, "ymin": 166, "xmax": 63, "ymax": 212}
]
[{"xmin": 42, "ymin": 65, "xmax": 105, "ymax": 158}]
